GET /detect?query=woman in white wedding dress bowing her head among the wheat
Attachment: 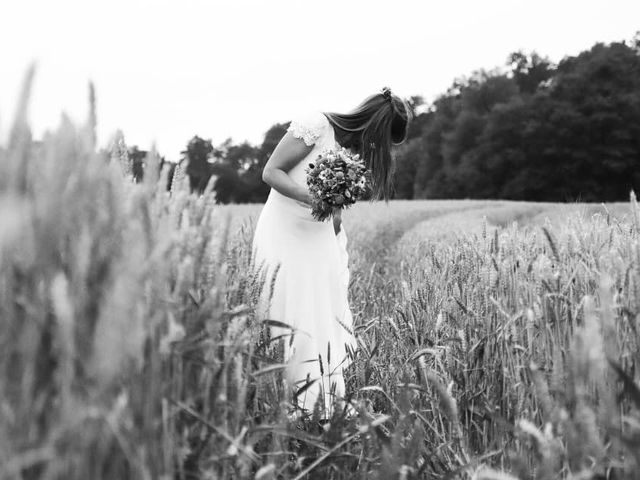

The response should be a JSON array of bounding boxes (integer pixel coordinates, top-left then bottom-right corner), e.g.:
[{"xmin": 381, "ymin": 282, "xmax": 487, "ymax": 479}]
[{"xmin": 253, "ymin": 87, "xmax": 412, "ymax": 418}]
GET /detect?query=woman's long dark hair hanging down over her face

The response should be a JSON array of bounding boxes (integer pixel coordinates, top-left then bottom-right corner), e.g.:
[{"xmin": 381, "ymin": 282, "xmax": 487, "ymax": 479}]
[{"xmin": 323, "ymin": 87, "xmax": 413, "ymax": 201}]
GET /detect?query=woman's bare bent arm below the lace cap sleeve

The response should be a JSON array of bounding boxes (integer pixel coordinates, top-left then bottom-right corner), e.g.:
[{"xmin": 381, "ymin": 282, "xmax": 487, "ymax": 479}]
[{"xmin": 262, "ymin": 132, "xmax": 313, "ymax": 205}]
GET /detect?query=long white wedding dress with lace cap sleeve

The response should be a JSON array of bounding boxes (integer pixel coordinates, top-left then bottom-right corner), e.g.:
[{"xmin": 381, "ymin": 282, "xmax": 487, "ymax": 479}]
[{"xmin": 253, "ymin": 112, "xmax": 356, "ymax": 416}]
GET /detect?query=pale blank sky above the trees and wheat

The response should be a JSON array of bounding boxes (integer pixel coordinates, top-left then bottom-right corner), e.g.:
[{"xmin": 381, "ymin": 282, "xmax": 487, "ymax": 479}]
[{"xmin": 0, "ymin": 0, "xmax": 640, "ymax": 160}]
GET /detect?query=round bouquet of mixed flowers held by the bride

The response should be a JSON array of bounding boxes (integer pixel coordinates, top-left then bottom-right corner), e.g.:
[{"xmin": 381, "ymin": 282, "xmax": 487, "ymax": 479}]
[{"xmin": 306, "ymin": 148, "xmax": 366, "ymax": 222}]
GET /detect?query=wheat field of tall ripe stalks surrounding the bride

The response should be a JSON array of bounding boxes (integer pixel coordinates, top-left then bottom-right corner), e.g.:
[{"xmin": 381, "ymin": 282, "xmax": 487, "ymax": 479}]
[{"xmin": 0, "ymin": 76, "xmax": 640, "ymax": 480}]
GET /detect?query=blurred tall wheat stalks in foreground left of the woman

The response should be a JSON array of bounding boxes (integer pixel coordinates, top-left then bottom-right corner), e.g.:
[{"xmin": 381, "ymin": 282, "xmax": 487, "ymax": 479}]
[{"xmin": 0, "ymin": 69, "xmax": 264, "ymax": 479}]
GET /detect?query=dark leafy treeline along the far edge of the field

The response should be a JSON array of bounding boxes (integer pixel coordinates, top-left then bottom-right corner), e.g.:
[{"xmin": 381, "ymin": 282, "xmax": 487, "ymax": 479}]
[{"xmin": 129, "ymin": 34, "xmax": 640, "ymax": 203}]
